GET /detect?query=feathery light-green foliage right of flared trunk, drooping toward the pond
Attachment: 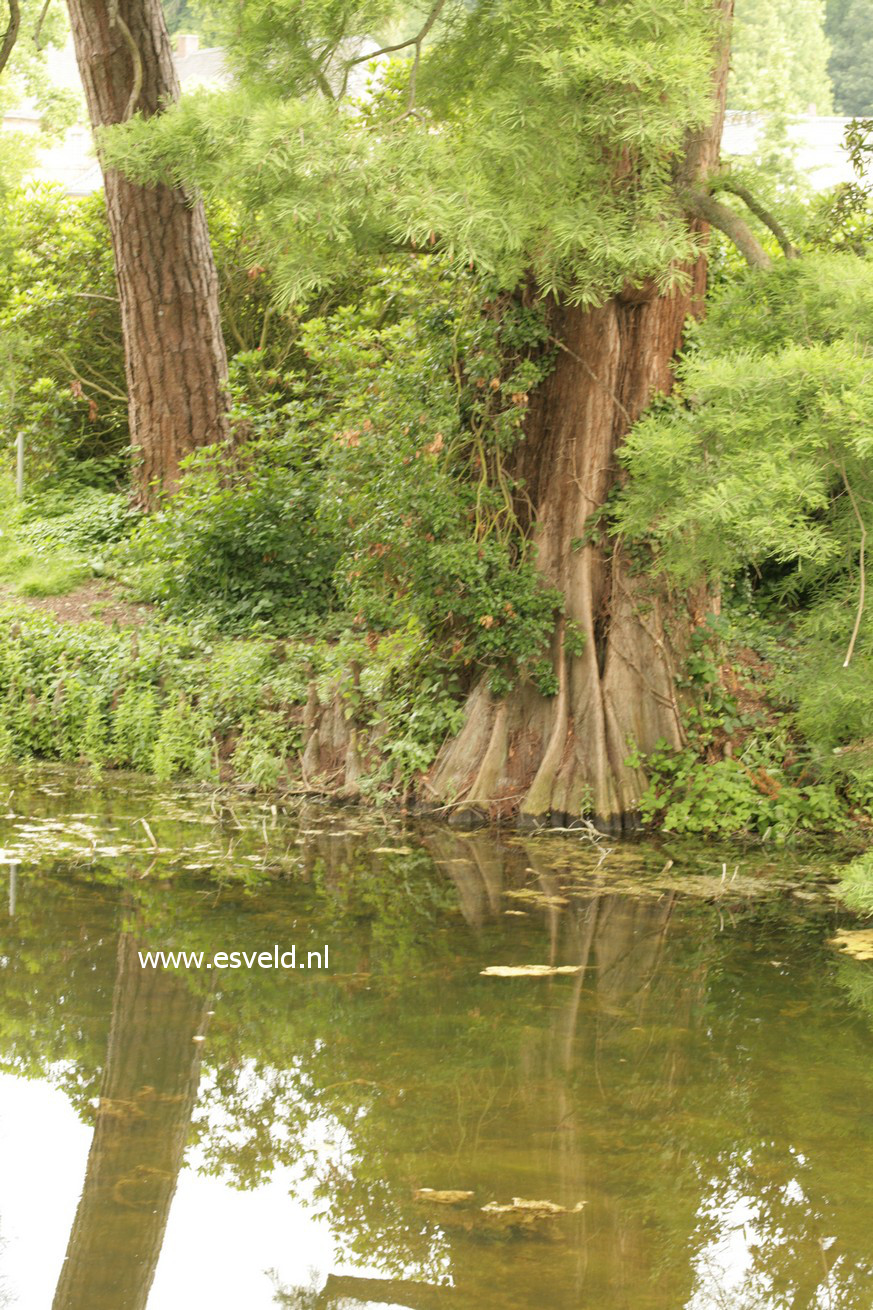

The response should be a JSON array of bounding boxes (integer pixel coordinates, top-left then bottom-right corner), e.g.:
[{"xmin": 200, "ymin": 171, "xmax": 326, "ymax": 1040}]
[{"xmin": 616, "ymin": 253, "xmax": 873, "ymax": 808}]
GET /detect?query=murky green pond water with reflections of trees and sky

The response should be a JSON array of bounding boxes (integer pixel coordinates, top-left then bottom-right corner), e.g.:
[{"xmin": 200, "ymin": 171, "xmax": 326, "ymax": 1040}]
[{"xmin": 0, "ymin": 770, "xmax": 873, "ymax": 1310}]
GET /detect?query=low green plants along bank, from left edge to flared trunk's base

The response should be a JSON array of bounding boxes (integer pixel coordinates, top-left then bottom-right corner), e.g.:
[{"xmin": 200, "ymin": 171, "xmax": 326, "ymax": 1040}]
[{"xmin": 0, "ymin": 605, "xmax": 461, "ymax": 798}]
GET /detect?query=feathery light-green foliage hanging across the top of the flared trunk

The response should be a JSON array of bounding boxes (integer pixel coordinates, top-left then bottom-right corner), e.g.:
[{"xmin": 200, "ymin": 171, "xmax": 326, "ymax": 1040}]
[{"xmin": 105, "ymin": 0, "xmax": 716, "ymax": 303}]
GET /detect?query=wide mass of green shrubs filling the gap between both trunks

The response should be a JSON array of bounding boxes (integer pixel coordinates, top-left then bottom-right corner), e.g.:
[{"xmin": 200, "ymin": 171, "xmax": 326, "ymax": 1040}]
[{"xmin": 120, "ymin": 259, "xmax": 557, "ymax": 685}]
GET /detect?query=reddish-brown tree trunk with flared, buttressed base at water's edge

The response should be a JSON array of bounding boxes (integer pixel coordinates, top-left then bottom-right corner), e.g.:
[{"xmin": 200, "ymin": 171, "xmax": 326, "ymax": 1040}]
[{"xmin": 427, "ymin": 10, "xmax": 730, "ymax": 832}]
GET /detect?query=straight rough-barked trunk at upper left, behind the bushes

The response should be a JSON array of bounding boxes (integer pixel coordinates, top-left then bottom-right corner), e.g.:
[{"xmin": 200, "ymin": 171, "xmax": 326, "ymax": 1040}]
[{"xmin": 69, "ymin": 0, "xmax": 228, "ymax": 502}]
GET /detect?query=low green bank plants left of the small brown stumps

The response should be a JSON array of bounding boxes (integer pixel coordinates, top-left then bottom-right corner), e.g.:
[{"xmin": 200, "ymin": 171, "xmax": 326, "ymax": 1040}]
[{"xmin": 0, "ymin": 607, "xmax": 305, "ymax": 783}]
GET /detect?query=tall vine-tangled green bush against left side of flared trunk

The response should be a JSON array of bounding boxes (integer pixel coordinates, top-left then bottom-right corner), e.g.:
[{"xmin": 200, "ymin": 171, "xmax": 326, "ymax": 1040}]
[{"xmin": 309, "ymin": 259, "xmax": 558, "ymax": 684}]
